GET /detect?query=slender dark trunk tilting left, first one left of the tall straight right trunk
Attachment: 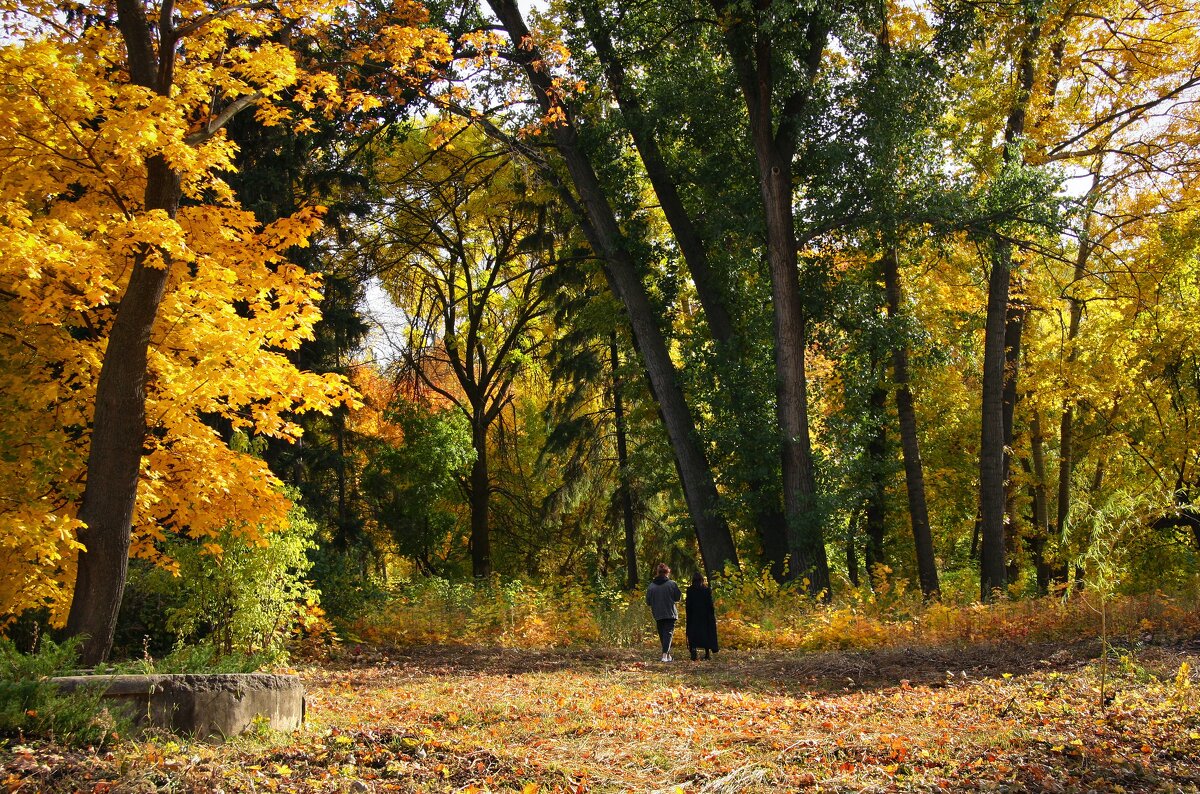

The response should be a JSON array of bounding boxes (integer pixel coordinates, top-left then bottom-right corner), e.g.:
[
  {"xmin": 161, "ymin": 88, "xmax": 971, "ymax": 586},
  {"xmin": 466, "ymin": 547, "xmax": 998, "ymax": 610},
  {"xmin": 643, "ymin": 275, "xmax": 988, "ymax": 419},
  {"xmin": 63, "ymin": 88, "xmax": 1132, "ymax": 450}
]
[{"xmin": 882, "ymin": 247, "xmax": 941, "ymax": 598}]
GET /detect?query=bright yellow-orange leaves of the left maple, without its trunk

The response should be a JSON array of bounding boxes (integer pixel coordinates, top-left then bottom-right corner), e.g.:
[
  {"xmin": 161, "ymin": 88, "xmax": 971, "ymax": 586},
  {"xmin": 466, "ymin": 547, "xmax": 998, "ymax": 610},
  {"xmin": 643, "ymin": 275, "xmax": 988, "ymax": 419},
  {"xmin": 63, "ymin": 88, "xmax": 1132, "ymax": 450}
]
[{"xmin": 0, "ymin": 0, "xmax": 445, "ymax": 628}]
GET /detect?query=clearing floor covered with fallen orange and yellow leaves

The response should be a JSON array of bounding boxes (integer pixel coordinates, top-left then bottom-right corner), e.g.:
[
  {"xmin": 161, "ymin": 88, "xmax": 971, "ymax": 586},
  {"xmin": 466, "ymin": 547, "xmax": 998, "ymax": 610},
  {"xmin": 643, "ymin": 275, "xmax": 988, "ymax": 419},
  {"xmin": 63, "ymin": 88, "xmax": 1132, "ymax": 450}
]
[{"xmin": 0, "ymin": 638, "xmax": 1200, "ymax": 794}]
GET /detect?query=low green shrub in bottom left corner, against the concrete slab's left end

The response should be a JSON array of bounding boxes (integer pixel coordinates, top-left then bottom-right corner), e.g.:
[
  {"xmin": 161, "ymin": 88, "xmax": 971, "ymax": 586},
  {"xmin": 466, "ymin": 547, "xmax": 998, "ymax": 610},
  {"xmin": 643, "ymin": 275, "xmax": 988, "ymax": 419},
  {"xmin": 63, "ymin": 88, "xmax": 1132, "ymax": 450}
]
[{"xmin": 0, "ymin": 638, "xmax": 127, "ymax": 745}]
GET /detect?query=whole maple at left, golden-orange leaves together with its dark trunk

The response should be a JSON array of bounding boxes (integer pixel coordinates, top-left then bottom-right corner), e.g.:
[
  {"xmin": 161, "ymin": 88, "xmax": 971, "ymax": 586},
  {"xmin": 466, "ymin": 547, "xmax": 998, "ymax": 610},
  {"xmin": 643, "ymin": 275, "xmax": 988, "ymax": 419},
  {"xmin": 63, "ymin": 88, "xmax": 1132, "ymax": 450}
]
[{"xmin": 0, "ymin": 0, "xmax": 439, "ymax": 662}]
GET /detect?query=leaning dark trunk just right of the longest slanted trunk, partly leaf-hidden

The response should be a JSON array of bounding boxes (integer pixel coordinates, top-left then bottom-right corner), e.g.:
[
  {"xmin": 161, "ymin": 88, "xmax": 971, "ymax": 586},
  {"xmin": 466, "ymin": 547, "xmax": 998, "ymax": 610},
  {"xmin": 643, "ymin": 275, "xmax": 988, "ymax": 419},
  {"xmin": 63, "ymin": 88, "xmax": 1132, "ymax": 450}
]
[{"xmin": 582, "ymin": 2, "xmax": 787, "ymax": 581}]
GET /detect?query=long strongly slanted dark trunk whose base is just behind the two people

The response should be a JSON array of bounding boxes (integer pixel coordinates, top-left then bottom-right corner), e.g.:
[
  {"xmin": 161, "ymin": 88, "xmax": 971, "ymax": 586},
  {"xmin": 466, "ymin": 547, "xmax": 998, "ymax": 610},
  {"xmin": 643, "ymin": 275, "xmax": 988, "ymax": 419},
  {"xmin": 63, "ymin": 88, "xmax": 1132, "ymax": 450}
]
[{"xmin": 488, "ymin": 0, "xmax": 738, "ymax": 575}]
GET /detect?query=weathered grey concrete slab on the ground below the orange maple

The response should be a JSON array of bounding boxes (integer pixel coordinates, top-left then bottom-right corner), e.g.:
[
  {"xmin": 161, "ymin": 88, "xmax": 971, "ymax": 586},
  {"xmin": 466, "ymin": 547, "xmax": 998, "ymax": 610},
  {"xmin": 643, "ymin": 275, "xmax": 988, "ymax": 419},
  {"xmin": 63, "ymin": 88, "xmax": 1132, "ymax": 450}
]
[{"xmin": 52, "ymin": 673, "xmax": 304, "ymax": 739}]
